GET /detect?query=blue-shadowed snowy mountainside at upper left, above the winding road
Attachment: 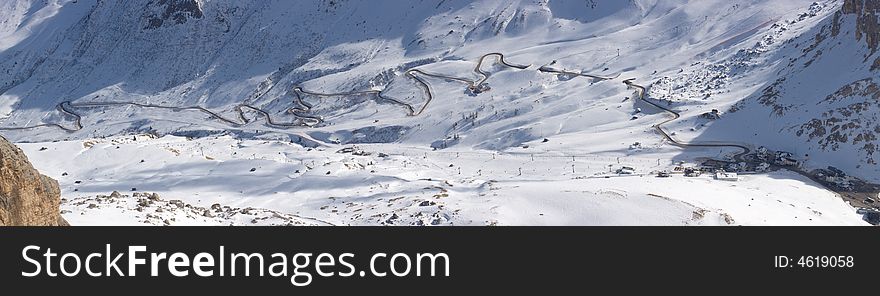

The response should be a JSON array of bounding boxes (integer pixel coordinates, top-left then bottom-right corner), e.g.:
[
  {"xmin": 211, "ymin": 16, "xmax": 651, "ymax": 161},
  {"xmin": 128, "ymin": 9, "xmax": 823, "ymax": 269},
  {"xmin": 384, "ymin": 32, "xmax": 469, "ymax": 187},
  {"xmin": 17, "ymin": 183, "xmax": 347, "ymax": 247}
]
[{"xmin": 0, "ymin": 0, "xmax": 638, "ymax": 116}]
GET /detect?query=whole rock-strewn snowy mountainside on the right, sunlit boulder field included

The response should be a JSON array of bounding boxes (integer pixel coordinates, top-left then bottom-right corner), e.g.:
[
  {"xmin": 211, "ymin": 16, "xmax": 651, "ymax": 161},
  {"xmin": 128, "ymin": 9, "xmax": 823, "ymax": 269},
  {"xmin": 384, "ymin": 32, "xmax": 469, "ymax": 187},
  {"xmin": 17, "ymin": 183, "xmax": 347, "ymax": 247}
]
[{"xmin": 652, "ymin": 0, "xmax": 880, "ymax": 182}]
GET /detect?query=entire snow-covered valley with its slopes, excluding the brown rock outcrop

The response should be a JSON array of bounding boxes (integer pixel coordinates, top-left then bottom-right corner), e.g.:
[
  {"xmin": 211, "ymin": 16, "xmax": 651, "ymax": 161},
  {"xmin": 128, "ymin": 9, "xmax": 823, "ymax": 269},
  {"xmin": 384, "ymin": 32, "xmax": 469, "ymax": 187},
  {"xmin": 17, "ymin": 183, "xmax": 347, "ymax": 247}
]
[{"xmin": 0, "ymin": 0, "xmax": 880, "ymax": 225}]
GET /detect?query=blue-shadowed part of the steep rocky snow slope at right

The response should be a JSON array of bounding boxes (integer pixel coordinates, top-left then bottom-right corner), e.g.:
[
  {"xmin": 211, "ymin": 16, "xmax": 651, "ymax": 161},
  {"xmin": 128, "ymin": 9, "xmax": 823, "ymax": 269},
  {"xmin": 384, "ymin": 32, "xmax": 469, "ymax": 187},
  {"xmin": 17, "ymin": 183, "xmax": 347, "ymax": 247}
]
[{"xmin": 688, "ymin": 0, "xmax": 880, "ymax": 180}]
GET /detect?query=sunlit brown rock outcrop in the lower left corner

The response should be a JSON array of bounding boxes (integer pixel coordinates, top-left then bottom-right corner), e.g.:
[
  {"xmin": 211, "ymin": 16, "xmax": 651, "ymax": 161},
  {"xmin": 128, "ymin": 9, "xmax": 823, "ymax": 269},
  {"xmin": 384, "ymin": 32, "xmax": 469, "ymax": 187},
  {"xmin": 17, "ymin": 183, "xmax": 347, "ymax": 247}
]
[{"xmin": 0, "ymin": 137, "xmax": 68, "ymax": 226}]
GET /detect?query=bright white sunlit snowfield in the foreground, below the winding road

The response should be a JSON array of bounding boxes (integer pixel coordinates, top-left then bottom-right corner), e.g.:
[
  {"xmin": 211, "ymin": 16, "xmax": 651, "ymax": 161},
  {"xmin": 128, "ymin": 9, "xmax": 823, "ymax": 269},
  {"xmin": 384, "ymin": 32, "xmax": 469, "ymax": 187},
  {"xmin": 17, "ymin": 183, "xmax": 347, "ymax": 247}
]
[{"xmin": 21, "ymin": 136, "xmax": 865, "ymax": 225}]
